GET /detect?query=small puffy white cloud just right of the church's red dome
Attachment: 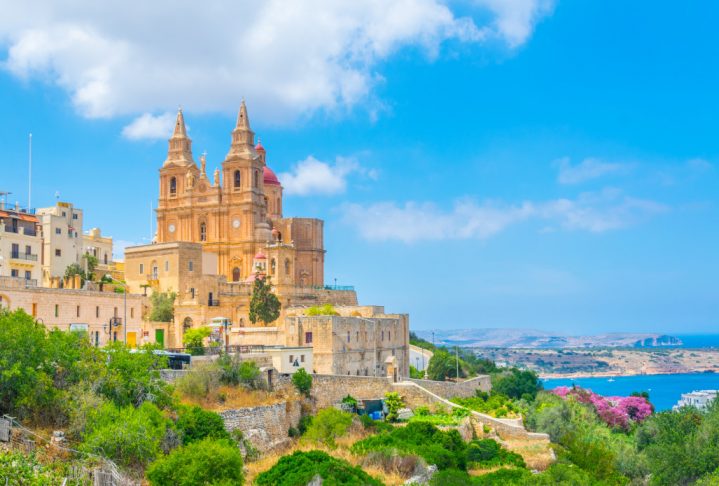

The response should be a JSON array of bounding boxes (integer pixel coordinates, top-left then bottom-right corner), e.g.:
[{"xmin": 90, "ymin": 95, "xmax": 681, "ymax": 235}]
[{"xmin": 277, "ymin": 155, "xmax": 377, "ymax": 196}]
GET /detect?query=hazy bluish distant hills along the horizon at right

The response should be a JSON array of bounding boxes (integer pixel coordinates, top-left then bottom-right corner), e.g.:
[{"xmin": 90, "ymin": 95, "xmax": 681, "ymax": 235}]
[{"xmin": 415, "ymin": 328, "xmax": 682, "ymax": 348}]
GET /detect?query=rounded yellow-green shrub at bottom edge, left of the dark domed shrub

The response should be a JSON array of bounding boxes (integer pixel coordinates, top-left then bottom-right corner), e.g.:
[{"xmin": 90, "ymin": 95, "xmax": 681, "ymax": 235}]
[{"xmin": 147, "ymin": 438, "xmax": 244, "ymax": 486}]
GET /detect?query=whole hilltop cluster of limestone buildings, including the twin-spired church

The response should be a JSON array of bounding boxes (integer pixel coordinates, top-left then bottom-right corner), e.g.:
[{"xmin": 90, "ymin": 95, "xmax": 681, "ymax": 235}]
[{"xmin": 0, "ymin": 101, "xmax": 409, "ymax": 378}]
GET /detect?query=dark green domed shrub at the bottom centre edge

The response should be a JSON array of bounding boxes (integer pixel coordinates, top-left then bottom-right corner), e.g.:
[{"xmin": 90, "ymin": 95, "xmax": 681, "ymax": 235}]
[{"xmin": 255, "ymin": 451, "xmax": 382, "ymax": 486}]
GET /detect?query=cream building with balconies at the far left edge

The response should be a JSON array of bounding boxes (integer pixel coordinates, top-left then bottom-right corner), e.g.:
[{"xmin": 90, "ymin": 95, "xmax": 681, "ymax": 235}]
[{"xmin": 0, "ymin": 203, "xmax": 42, "ymax": 286}]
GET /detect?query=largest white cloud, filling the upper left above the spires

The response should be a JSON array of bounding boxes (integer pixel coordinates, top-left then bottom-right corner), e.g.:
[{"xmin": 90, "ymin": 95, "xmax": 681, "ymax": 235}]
[{"xmin": 0, "ymin": 0, "xmax": 551, "ymax": 122}]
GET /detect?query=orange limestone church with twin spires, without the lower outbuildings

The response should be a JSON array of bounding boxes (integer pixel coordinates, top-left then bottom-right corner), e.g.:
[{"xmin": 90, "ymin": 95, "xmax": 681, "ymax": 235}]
[{"xmin": 158, "ymin": 101, "xmax": 325, "ymax": 287}]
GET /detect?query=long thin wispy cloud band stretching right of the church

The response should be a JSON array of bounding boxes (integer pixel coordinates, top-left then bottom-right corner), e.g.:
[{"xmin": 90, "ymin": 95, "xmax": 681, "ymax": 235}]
[{"xmin": 342, "ymin": 189, "xmax": 668, "ymax": 243}]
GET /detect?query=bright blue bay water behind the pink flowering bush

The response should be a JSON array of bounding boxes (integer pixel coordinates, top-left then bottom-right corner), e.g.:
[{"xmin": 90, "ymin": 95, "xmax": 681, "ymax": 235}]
[{"xmin": 543, "ymin": 373, "xmax": 719, "ymax": 411}]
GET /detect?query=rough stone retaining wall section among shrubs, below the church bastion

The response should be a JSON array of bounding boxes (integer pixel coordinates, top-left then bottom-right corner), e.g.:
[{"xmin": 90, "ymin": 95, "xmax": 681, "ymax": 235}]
[{"xmin": 220, "ymin": 401, "xmax": 302, "ymax": 452}]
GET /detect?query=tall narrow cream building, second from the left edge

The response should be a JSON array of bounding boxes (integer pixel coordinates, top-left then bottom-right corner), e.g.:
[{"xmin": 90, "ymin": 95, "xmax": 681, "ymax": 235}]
[{"xmin": 37, "ymin": 202, "xmax": 84, "ymax": 286}]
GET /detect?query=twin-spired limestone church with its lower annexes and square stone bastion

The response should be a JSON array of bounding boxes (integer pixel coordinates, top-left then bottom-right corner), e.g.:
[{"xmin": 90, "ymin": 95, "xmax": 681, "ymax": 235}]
[{"xmin": 124, "ymin": 102, "xmax": 409, "ymax": 376}]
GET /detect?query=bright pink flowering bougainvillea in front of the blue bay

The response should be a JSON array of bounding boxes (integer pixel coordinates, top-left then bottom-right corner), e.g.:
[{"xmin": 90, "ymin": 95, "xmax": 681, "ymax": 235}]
[{"xmin": 552, "ymin": 386, "xmax": 652, "ymax": 430}]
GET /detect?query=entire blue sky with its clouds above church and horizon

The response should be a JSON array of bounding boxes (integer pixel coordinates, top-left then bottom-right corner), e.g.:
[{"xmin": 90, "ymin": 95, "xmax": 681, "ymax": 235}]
[{"xmin": 0, "ymin": 0, "xmax": 719, "ymax": 334}]
